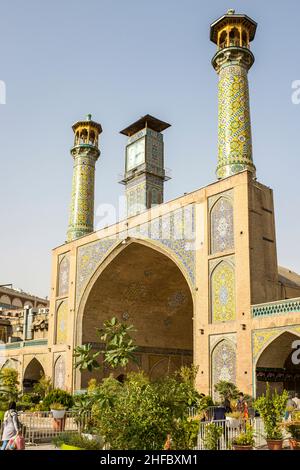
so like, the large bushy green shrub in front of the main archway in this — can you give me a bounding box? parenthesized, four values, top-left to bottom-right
(92, 371, 204, 450)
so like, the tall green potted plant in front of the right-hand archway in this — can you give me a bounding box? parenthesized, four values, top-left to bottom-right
(254, 383, 288, 450)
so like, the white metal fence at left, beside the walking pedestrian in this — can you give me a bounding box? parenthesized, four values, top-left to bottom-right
(0, 411, 90, 443)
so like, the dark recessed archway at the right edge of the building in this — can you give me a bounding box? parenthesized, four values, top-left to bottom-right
(256, 331, 300, 396)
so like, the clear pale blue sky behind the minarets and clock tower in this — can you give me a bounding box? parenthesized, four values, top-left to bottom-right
(0, 0, 300, 295)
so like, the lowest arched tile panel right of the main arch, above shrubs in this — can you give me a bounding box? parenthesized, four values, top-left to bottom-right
(211, 339, 236, 399)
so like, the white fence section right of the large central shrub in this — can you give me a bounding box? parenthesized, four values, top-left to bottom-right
(196, 418, 266, 450)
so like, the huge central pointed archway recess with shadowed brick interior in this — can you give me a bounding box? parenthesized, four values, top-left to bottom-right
(76, 241, 193, 388)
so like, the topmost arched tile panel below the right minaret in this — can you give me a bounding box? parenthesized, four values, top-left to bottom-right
(210, 197, 234, 253)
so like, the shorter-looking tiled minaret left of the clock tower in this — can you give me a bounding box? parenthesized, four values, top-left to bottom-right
(67, 114, 102, 242)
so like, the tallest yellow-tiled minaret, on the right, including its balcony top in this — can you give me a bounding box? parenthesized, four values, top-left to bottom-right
(210, 10, 257, 179)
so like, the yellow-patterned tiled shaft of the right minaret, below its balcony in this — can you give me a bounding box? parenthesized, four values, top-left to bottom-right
(217, 65, 255, 178)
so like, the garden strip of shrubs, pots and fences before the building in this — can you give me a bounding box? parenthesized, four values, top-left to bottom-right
(0, 318, 300, 450)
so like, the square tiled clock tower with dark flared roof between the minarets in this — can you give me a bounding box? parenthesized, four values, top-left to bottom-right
(121, 114, 170, 217)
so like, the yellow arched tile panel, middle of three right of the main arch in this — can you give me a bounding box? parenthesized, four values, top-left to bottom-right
(211, 261, 236, 322)
